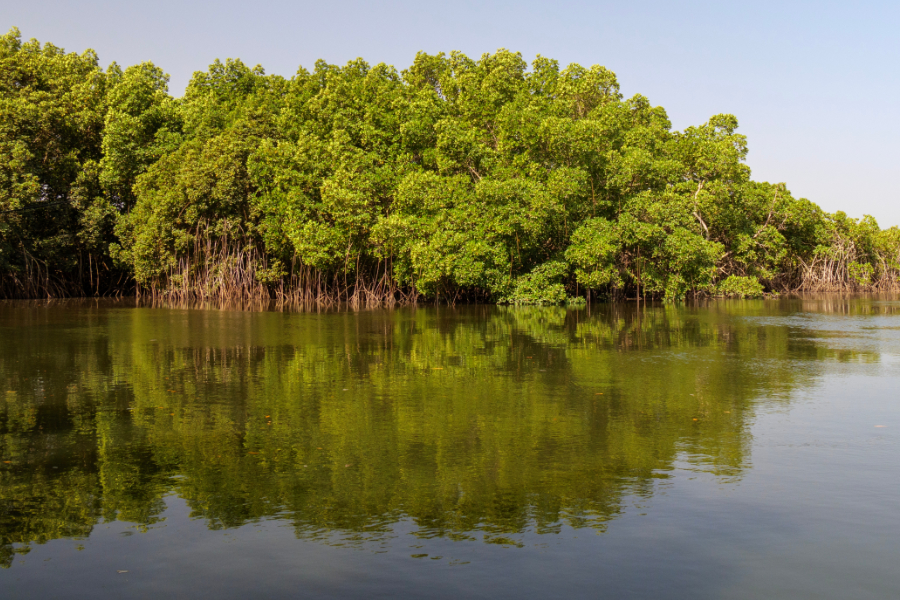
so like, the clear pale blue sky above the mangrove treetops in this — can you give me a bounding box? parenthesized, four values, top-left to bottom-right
(7, 0, 900, 227)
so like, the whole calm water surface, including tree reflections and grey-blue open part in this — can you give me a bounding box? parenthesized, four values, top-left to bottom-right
(0, 297, 900, 599)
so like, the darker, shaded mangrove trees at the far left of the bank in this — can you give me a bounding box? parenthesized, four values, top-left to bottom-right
(0, 29, 113, 297)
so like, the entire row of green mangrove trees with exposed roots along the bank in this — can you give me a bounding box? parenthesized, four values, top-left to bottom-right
(0, 29, 900, 304)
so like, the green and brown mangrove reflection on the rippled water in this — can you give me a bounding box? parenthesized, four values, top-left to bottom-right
(0, 301, 884, 566)
